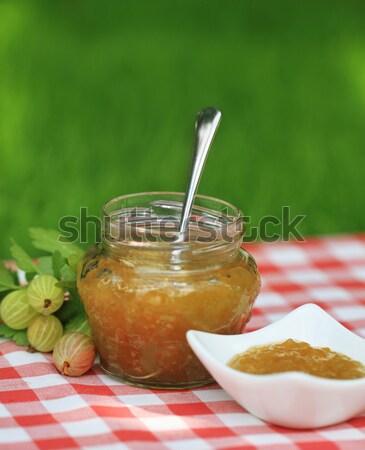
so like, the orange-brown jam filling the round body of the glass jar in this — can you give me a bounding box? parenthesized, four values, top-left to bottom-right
(78, 244, 260, 388)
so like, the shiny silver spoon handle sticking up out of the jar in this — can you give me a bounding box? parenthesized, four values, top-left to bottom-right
(179, 108, 222, 233)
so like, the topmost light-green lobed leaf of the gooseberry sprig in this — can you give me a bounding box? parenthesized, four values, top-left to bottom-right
(29, 228, 84, 258)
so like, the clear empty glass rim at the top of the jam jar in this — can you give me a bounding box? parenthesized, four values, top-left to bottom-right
(102, 191, 245, 254)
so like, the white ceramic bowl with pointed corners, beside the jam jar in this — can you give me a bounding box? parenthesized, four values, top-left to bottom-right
(187, 303, 365, 428)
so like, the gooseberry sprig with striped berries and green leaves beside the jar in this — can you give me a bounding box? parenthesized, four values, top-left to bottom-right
(0, 228, 95, 376)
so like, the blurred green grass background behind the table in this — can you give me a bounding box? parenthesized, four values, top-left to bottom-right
(0, 0, 365, 257)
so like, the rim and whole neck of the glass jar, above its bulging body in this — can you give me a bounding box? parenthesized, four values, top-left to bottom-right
(102, 192, 244, 270)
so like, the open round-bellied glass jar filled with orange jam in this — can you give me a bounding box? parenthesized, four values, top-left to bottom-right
(78, 192, 260, 389)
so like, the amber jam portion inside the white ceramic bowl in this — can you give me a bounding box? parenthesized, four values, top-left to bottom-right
(228, 339, 365, 380)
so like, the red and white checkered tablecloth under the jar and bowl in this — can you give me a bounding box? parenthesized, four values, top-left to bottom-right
(0, 234, 365, 450)
